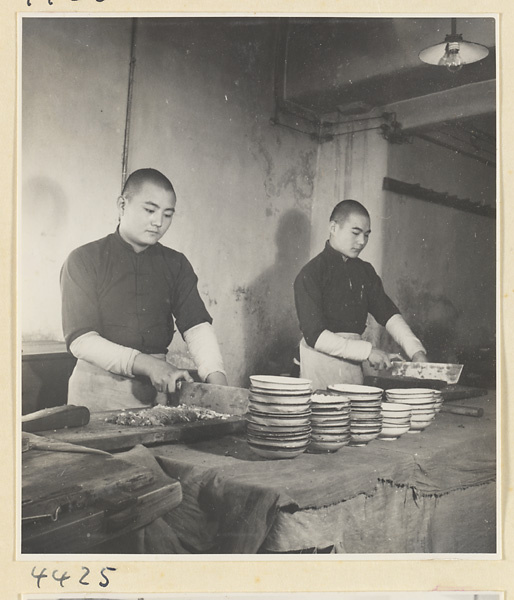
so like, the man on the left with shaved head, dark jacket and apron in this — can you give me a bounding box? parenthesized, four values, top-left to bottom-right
(61, 169, 227, 411)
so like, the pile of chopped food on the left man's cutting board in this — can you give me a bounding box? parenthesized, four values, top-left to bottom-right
(105, 404, 231, 427)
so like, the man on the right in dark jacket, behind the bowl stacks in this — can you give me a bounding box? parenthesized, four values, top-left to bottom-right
(294, 200, 427, 389)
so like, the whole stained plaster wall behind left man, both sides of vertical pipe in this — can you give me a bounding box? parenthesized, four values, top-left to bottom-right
(20, 19, 317, 385)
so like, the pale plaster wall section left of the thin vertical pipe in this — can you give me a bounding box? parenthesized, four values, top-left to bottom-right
(18, 19, 130, 341)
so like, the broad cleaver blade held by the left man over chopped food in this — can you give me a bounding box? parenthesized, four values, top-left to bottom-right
(170, 381, 250, 415)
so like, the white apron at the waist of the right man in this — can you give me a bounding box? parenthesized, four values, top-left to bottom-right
(300, 333, 363, 390)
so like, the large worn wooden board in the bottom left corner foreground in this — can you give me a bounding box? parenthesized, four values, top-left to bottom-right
(22, 450, 182, 553)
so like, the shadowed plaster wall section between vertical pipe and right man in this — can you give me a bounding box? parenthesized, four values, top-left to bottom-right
(124, 19, 317, 385)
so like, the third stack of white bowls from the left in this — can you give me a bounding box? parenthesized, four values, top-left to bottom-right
(328, 383, 383, 446)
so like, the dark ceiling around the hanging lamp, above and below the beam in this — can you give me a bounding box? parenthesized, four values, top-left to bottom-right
(282, 17, 496, 160)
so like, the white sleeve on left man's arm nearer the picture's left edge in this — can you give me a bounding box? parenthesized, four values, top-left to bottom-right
(70, 331, 140, 377)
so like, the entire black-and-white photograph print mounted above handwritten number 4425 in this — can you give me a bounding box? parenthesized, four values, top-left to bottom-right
(17, 13, 500, 556)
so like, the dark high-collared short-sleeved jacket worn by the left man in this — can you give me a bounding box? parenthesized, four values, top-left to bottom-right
(61, 231, 212, 354)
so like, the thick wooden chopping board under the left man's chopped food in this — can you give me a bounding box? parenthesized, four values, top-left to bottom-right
(40, 411, 245, 452)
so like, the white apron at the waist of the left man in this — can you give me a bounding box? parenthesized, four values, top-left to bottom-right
(68, 354, 167, 412)
